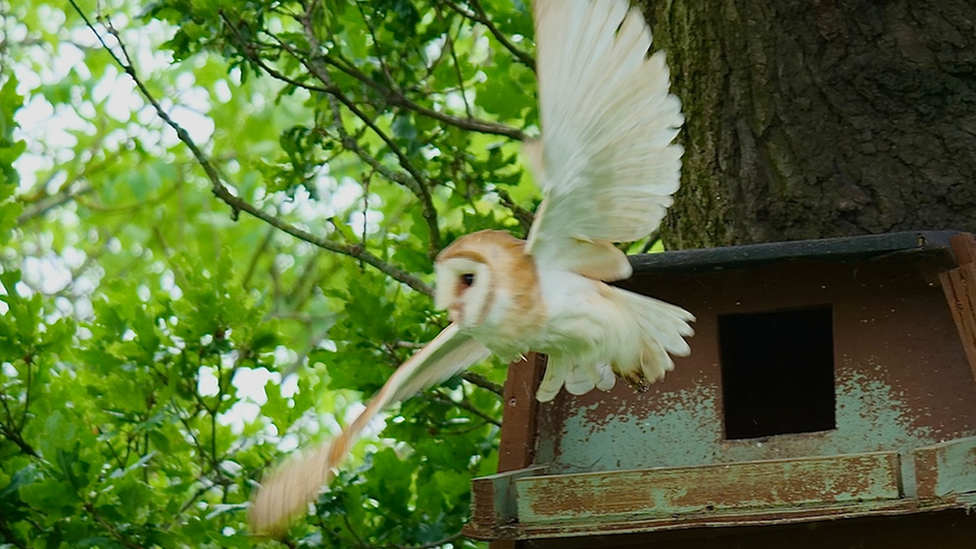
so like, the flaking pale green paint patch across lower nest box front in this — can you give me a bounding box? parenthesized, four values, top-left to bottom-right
(540, 364, 938, 484)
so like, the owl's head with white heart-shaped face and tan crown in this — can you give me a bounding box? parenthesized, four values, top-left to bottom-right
(434, 231, 537, 329)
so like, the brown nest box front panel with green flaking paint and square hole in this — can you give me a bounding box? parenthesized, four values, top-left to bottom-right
(534, 257, 976, 478)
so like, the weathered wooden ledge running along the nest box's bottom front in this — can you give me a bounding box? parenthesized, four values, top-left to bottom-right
(465, 437, 976, 540)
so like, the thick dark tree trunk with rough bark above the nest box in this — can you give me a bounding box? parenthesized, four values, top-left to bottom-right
(642, 0, 976, 248)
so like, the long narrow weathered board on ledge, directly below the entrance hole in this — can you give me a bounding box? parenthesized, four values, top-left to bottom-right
(515, 452, 900, 524)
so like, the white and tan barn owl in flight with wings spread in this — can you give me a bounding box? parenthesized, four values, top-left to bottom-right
(251, 0, 694, 531)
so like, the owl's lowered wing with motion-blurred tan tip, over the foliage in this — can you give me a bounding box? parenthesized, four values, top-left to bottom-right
(250, 324, 491, 533)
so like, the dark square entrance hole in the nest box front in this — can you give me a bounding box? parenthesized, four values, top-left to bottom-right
(718, 306, 836, 440)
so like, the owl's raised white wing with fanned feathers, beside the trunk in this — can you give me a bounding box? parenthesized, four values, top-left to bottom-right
(526, 0, 684, 281)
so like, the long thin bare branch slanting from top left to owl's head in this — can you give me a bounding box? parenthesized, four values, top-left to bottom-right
(69, 0, 434, 296)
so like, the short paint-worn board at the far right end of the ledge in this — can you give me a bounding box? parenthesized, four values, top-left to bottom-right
(915, 437, 976, 502)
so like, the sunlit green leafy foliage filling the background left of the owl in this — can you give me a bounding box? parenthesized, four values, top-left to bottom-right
(0, 0, 572, 549)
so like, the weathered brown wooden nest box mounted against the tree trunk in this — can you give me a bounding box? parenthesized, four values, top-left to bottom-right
(466, 232, 976, 549)
